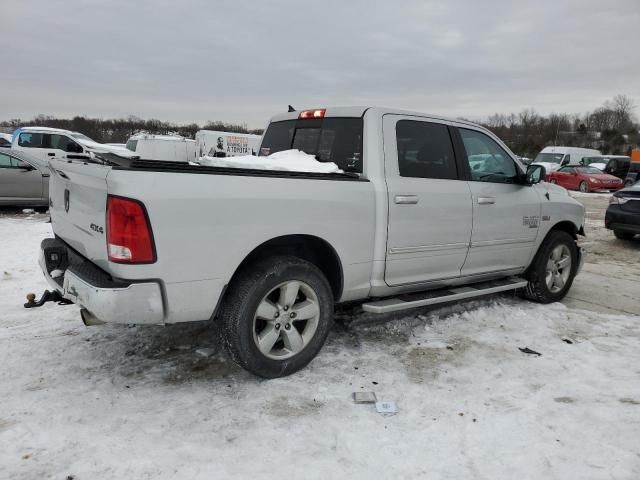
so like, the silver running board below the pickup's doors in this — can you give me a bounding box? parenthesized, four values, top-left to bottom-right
(362, 277, 528, 313)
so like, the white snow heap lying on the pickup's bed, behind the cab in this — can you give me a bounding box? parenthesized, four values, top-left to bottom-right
(198, 150, 342, 173)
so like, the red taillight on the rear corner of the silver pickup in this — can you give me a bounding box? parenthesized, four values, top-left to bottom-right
(107, 195, 156, 263)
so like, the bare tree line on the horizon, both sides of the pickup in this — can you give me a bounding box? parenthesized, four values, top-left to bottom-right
(0, 95, 640, 157)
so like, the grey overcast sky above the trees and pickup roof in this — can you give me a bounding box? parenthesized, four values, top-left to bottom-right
(0, 0, 640, 127)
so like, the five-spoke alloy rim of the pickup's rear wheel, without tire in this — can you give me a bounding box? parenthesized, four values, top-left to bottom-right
(253, 280, 320, 360)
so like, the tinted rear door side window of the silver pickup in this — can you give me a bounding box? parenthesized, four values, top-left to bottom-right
(396, 120, 458, 180)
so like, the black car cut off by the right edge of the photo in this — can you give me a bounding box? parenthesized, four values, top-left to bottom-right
(604, 183, 640, 240)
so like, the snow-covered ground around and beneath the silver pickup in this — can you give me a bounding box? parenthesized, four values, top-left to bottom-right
(0, 215, 640, 480)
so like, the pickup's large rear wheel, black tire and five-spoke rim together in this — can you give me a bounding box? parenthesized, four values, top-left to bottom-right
(219, 256, 333, 378)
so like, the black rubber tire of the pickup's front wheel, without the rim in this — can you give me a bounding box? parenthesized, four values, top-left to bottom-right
(522, 230, 578, 303)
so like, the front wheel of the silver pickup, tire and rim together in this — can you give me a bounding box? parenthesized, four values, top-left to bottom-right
(523, 230, 578, 303)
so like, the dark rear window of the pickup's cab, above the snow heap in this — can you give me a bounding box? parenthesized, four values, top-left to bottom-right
(259, 117, 362, 173)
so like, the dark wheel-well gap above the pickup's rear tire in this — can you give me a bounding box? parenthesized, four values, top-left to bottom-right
(229, 235, 344, 300)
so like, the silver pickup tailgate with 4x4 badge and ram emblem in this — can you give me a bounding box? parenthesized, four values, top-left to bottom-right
(49, 160, 111, 270)
